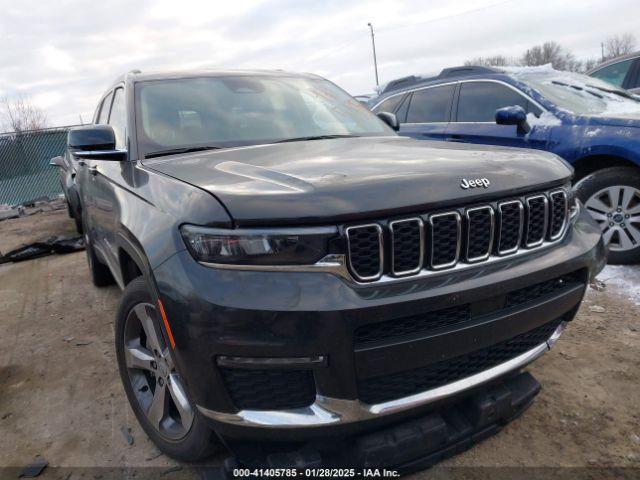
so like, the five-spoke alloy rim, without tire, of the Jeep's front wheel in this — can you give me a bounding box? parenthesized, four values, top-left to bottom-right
(124, 303, 193, 440)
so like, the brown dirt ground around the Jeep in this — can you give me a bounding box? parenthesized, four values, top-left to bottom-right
(0, 210, 640, 479)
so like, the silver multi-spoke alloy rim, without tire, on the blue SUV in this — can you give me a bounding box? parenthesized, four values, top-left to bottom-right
(585, 185, 640, 252)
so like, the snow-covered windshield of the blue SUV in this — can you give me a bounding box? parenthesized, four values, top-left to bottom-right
(514, 71, 640, 116)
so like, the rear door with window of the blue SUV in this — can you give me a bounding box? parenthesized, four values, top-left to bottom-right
(398, 83, 456, 140)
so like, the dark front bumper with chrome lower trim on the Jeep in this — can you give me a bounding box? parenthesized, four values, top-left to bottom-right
(154, 207, 606, 439)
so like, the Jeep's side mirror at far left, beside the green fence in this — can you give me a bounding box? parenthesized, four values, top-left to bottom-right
(67, 125, 127, 160)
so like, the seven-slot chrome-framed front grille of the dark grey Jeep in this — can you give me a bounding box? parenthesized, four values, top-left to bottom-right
(345, 190, 568, 282)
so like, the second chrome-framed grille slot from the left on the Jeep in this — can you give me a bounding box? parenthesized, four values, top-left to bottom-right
(389, 218, 424, 277)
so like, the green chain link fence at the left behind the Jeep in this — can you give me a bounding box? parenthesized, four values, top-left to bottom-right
(0, 127, 79, 205)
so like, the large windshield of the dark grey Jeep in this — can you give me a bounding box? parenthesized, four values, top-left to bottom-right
(136, 75, 394, 156)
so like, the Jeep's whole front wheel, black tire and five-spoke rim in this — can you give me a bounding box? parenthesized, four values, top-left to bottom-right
(116, 277, 219, 461)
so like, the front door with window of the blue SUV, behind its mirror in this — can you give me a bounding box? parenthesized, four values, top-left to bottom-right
(446, 80, 550, 149)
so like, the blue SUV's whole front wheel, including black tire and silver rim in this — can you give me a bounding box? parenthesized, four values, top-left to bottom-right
(575, 167, 640, 264)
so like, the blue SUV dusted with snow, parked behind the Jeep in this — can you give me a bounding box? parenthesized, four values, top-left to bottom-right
(368, 66, 640, 263)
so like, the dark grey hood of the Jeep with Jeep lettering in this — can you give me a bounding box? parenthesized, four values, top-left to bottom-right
(144, 136, 572, 226)
